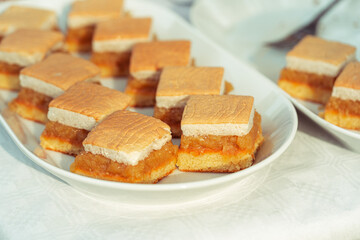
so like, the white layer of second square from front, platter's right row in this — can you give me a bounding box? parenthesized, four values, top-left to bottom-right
(156, 78, 225, 108)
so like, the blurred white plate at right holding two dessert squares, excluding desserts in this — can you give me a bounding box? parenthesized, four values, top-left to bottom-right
(190, 0, 360, 152)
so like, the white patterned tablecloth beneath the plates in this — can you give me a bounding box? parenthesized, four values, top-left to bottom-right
(0, 0, 360, 239)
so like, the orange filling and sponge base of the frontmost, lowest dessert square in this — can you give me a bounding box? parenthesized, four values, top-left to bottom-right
(70, 141, 178, 183)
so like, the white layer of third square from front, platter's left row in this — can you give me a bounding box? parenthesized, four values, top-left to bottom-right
(19, 74, 100, 98)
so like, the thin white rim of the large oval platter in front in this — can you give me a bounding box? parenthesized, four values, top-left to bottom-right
(0, 0, 298, 192)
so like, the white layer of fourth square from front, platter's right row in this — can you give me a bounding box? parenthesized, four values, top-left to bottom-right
(93, 38, 149, 52)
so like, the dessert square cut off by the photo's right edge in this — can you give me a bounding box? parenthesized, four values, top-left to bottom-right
(324, 62, 360, 130)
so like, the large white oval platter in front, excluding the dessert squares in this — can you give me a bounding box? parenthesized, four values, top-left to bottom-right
(0, 0, 297, 204)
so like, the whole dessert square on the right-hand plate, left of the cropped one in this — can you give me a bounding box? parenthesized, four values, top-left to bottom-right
(278, 36, 356, 104)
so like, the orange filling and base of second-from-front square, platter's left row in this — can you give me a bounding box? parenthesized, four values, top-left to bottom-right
(40, 121, 89, 155)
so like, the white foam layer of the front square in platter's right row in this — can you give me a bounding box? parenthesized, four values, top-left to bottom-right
(181, 107, 255, 136)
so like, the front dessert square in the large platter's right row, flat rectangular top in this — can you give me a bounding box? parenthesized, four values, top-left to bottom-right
(176, 95, 264, 172)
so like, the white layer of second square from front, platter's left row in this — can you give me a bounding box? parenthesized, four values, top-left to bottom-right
(47, 107, 96, 131)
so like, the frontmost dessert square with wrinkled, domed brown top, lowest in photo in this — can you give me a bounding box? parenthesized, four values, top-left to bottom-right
(70, 110, 178, 183)
